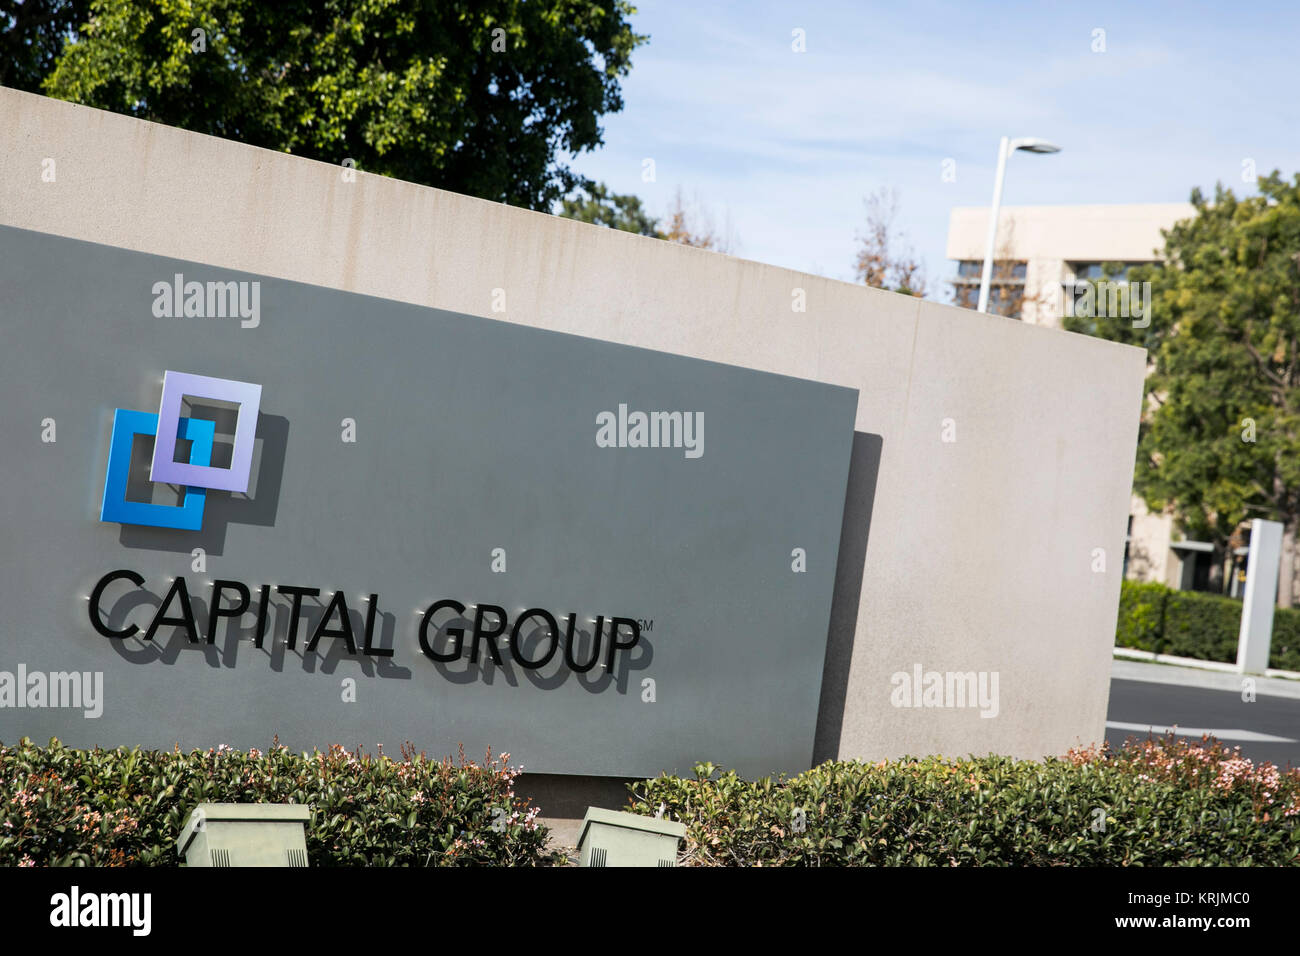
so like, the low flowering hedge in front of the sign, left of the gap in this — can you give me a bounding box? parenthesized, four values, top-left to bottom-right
(0, 739, 555, 866)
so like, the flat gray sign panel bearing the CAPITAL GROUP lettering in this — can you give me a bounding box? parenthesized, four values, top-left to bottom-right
(0, 228, 857, 775)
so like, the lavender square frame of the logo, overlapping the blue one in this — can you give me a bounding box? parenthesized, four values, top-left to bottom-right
(150, 372, 261, 493)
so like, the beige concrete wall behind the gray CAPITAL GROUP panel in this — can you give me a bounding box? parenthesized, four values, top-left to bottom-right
(0, 90, 1145, 760)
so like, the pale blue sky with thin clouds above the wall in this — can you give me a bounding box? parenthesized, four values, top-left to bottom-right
(573, 0, 1300, 298)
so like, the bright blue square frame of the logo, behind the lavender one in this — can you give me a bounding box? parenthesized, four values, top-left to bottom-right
(99, 408, 217, 531)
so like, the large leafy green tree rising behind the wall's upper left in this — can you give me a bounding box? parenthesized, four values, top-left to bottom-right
(44, 0, 646, 209)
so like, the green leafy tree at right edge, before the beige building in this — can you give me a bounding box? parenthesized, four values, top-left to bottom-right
(1066, 172, 1300, 606)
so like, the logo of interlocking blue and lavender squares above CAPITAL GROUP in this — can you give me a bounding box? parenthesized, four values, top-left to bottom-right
(99, 371, 261, 531)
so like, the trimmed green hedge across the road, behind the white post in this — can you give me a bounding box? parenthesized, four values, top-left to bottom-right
(1115, 581, 1300, 670)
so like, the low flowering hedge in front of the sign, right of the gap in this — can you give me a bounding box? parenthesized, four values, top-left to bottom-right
(629, 737, 1300, 866)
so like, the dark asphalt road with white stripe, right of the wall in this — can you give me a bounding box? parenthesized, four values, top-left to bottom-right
(1106, 679, 1300, 767)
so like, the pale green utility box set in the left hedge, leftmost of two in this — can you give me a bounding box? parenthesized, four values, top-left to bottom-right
(176, 804, 312, 866)
